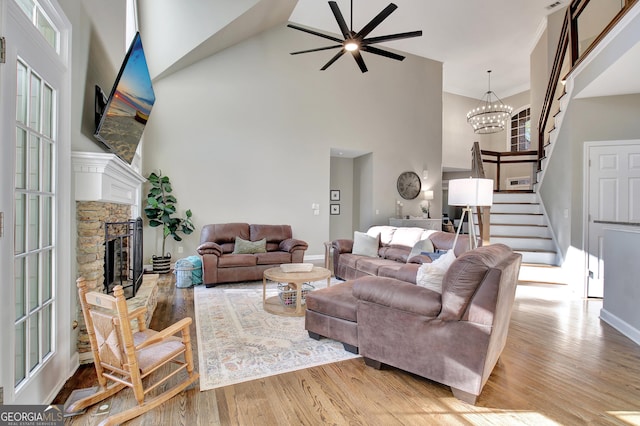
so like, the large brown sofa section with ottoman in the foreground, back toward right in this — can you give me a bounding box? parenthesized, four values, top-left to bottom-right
(305, 244, 522, 404)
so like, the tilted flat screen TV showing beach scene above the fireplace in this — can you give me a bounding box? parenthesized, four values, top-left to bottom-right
(94, 33, 156, 164)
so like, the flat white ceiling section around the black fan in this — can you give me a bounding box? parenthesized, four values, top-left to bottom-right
(290, 0, 568, 98)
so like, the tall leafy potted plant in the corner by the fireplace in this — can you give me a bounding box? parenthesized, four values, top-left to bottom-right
(144, 172, 195, 274)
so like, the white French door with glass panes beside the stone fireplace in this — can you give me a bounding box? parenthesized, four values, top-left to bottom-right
(0, 0, 71, 404)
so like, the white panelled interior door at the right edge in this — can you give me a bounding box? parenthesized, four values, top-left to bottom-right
(587, 141, 640, 297)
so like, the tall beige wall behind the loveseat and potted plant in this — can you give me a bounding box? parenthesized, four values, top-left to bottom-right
(143, 26, 442, 258)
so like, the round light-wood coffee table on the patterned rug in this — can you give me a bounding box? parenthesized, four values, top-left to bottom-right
(262, 266, 331, 317)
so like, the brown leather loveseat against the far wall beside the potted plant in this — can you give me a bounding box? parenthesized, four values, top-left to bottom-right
(198, 223, 308, 287)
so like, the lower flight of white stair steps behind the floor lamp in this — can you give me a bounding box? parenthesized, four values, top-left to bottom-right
(482, 192, 558, 265)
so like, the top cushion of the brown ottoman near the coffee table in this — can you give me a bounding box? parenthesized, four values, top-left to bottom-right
(306, 281, 358, 322)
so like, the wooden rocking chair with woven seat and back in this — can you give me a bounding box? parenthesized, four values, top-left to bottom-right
(67, 278, 198, 425)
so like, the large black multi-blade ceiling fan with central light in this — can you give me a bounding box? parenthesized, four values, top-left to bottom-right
(287, 0, 422, 73)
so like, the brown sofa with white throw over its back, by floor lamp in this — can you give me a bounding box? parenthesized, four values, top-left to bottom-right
(331, 226, 469, 284)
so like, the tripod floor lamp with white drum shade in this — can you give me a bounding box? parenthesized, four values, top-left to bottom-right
(448, 178, 493, 250)
